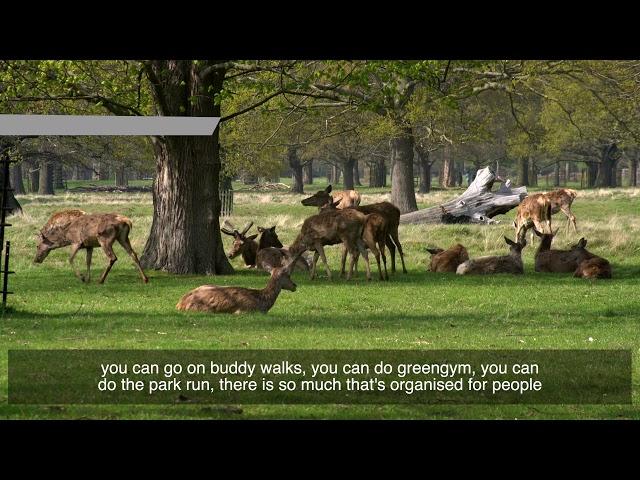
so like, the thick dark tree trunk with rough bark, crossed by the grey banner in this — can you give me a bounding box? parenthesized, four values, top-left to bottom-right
(142, 60, 233, 275)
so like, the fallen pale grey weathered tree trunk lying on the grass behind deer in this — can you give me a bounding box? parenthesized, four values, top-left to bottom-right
(400, 167, 527, 224)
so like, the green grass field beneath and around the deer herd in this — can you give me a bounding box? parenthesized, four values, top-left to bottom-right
(0, 184, 640, 419)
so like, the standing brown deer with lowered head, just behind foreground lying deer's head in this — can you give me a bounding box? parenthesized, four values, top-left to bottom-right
(289, 204, 371, 280)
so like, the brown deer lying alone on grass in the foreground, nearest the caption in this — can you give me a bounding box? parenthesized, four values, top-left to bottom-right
(176, 251, 298, 314)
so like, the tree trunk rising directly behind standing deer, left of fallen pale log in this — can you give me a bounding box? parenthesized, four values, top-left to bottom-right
(391, 127, 418, 213)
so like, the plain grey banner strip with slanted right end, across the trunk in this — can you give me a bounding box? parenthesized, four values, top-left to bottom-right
(0, 115, 220, 136)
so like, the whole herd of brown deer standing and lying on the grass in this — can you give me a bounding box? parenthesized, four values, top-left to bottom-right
(34, 185, 611, 313)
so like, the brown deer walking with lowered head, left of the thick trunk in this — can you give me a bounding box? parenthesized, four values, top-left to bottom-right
(34, 210, 149, 283)
